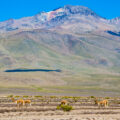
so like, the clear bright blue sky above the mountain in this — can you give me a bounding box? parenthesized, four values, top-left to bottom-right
(0, 0, 120, 21)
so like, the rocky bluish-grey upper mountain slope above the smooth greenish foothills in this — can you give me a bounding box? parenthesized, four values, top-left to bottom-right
(0, 5, 119, 32)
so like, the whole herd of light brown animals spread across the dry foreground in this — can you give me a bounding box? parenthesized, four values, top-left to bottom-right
(11, 98, 108, 108)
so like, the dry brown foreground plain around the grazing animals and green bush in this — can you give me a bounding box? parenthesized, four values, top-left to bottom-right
(0, 96, 120, 120)
